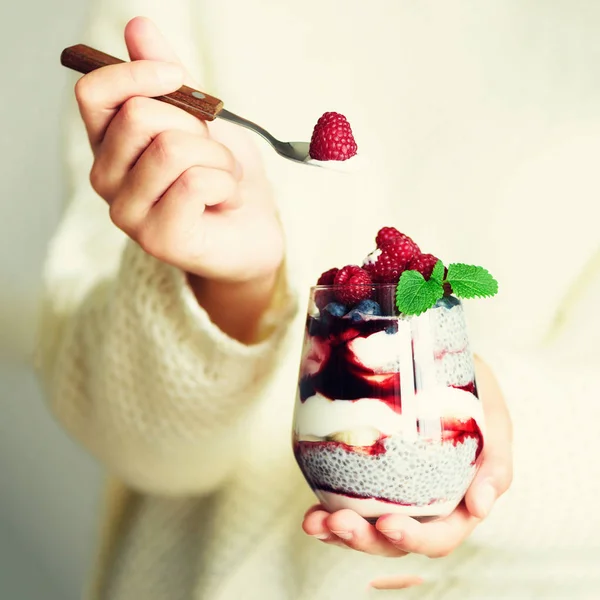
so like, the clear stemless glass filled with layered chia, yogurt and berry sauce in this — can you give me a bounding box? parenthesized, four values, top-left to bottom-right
(293, 284, 484, 520)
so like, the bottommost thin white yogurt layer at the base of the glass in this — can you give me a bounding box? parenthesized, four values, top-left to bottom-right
(315, 490, 460, 518)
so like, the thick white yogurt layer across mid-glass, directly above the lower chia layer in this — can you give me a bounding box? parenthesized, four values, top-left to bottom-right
(294, 387, 483, 445)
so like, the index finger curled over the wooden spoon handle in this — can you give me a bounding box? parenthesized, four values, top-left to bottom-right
(75, 60, 184, 152)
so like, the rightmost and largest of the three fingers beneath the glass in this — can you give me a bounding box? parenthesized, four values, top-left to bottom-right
(375, 504, 480, 558)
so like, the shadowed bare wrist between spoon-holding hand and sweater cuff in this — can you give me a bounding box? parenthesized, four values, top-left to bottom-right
(186, 269, 278, 344)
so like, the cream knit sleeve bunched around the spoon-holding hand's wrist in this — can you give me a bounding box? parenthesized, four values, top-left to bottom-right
(40, 223, 293, 494)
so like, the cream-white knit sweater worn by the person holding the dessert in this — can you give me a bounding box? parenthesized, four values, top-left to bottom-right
(39, 0, 600, 600)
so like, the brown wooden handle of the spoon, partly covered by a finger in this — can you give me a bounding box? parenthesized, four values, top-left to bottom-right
(60, 44, 223, 121)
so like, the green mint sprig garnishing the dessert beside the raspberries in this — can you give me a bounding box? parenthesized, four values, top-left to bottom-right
(396, 260, 498, 315)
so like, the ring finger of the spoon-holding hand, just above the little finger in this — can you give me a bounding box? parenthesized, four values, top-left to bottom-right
(110, 130, 236, 236)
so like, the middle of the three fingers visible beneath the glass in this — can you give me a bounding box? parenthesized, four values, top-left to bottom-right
(327, 509, 406, 556)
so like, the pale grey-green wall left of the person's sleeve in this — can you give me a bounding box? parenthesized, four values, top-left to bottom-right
(0, 0, 100, 600)
